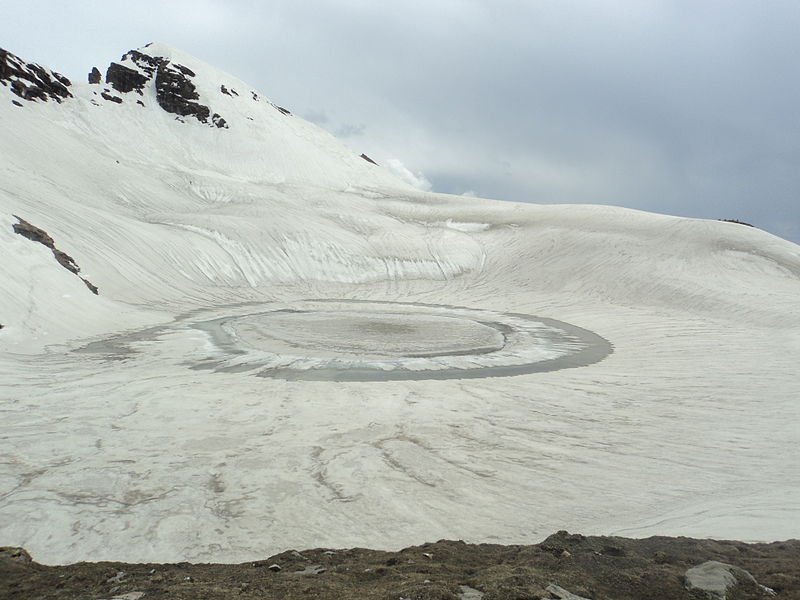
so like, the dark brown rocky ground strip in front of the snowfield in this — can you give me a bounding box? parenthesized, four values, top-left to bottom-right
(0, 531, 800, 600)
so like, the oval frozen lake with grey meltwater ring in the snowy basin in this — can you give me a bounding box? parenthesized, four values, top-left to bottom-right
(191, 300, 612, 381)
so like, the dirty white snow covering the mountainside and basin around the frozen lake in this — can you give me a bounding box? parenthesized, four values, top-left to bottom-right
(0, 44, 800, 562)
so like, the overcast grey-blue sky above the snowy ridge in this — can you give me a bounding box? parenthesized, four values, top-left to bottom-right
(6, 0, 800, 242)
